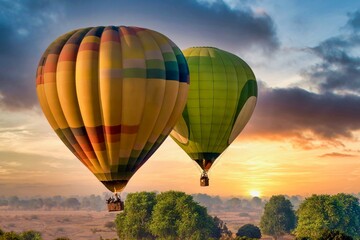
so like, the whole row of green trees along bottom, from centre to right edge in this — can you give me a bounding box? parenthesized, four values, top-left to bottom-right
(115, 191, 360, 240)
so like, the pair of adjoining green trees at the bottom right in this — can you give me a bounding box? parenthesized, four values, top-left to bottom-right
(260, 193, 360, 240)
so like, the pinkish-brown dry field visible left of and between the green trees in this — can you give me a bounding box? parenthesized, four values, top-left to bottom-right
(0, 209, 293, 240)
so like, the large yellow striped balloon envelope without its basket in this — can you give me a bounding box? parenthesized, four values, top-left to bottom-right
(36, 26, 189, 209)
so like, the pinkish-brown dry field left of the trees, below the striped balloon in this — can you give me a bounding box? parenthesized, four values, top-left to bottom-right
(0, 210, 116, 240)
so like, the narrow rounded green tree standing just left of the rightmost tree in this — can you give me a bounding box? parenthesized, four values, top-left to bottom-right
(260, 195, 296, 239)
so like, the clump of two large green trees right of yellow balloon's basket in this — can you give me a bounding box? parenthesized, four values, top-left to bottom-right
(115, 191, 220, 240)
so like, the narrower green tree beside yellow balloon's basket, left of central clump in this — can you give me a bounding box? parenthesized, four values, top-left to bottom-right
(115, 192, 156, 239)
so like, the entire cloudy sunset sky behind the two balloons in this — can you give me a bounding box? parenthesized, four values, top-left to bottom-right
(0, 0, 360, 196)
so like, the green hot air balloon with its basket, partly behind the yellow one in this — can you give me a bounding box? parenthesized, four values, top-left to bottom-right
(171, 47, 257, 186)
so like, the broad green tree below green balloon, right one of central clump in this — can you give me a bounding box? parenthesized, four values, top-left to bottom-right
(150, 191, 220, 240)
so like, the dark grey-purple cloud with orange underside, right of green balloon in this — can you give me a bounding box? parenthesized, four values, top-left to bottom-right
(246, 84, 360, 145)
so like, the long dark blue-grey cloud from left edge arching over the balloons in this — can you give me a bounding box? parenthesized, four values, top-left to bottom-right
(0, 0, 279, 109)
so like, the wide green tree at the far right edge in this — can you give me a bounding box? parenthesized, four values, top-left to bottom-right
(295, 194, 360, 239)
